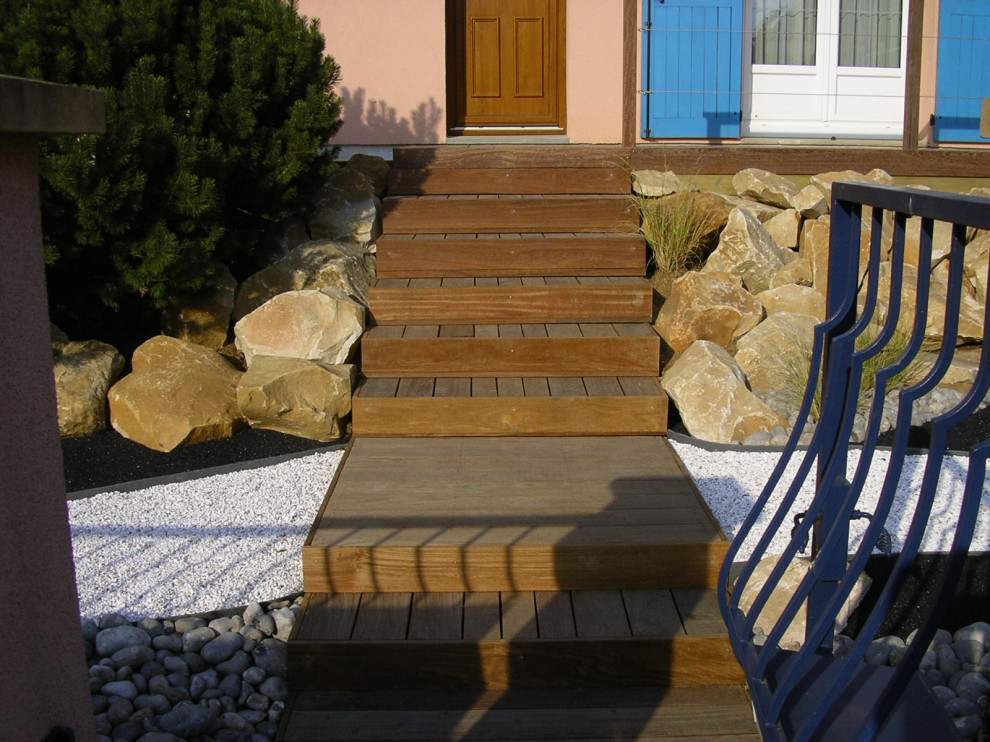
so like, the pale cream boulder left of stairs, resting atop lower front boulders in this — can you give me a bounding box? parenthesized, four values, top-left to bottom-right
(234, 288, 365, 369)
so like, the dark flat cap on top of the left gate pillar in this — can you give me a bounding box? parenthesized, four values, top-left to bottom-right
(0, 75, 106, 134)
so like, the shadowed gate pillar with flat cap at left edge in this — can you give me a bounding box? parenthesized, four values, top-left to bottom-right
(0, 77, 104, 742)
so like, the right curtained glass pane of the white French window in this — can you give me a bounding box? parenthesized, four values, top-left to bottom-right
(839, 0, 903, 68)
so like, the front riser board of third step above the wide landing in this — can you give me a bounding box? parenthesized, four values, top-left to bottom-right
(370, 282, 653, 325)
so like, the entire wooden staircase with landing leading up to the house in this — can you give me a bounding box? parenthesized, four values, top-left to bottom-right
(280, 148, 759, 742)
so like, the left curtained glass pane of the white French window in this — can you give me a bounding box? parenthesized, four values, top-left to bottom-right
(753, 0, 818, 65)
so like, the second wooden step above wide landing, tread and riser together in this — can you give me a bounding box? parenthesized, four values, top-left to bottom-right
(361, 324, 660, 378)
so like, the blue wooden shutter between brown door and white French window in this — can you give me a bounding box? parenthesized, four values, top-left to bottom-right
(643, 0, 743, 138)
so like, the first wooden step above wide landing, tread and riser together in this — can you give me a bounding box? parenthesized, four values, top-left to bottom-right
(352, 376, 667, 436)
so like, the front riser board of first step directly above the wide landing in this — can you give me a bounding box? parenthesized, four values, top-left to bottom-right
(352, 396, 667, 437)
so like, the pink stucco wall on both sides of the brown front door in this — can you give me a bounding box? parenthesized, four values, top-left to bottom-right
(299, 0, 622, 145)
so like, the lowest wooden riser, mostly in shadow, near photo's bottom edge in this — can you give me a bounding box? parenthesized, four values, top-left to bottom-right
(289, 637, 745, 691)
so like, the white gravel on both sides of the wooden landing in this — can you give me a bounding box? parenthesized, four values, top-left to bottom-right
(69, 441, 990, 619)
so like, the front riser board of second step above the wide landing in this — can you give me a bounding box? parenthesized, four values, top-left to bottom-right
(361, 337, 660, 378)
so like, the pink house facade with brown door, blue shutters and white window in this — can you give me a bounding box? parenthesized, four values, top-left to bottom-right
(299, 0, 990, 154)
